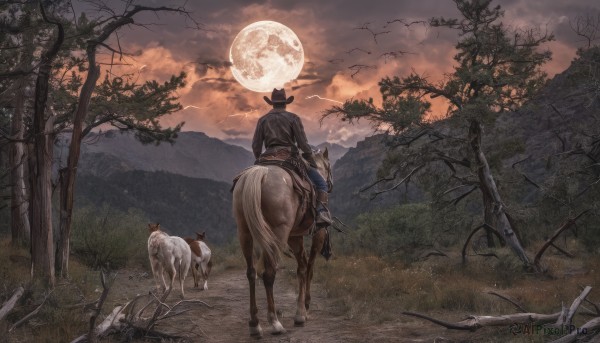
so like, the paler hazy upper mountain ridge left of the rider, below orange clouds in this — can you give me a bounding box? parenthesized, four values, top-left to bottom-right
(62, 131, 254, 182)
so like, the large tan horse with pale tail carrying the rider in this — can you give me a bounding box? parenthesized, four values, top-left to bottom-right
(233, 149, 333, 337)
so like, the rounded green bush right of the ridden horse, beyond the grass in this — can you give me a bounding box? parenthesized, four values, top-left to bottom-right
(339, 203, 435, 256)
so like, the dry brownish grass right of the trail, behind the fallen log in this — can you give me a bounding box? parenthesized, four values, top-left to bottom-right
(315, 241, 600, 330)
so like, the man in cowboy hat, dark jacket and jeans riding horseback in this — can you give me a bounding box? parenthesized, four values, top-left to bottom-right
(252, 88, 331, 227)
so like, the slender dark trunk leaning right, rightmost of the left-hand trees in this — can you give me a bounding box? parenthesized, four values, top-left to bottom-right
(56, 46, 100, 277)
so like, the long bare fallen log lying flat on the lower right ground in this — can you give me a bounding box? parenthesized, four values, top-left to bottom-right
(402, 312, 561, 331)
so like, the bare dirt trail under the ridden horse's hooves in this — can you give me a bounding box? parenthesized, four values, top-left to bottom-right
(105, 264, 492, 343)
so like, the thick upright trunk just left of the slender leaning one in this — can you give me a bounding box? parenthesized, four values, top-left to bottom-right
(30, 63, 55, 287)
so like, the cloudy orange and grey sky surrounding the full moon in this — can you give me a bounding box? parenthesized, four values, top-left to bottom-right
(82, 0, 600, 146)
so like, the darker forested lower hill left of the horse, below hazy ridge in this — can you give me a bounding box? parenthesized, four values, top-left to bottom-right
(75, 170, 236, 244)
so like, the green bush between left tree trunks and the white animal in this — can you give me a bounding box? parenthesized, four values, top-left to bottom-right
(71, 205, 148, 269)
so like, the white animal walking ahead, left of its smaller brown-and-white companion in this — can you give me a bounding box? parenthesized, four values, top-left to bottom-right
(148, 224, 192, 299)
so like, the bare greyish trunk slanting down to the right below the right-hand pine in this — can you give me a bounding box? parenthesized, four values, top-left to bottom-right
(469, 120, 531, 266)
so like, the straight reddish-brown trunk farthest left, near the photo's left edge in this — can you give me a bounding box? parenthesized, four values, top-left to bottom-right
(9, 82, 31, 246)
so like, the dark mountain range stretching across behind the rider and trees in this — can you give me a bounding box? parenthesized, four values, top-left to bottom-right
(70, 48, 600, 243)
